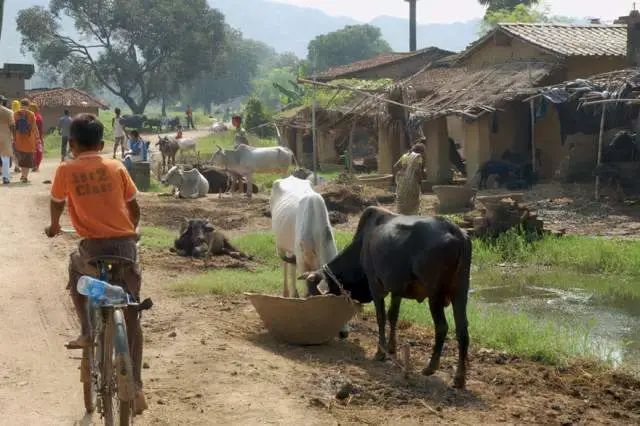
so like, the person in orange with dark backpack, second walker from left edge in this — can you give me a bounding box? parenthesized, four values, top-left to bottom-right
(13, 99, 38, 183)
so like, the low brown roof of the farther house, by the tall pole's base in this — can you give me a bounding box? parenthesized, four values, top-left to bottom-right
(314, 47, 453, 81)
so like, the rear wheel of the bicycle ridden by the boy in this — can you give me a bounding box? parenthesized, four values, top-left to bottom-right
(102, 309, 134, 426)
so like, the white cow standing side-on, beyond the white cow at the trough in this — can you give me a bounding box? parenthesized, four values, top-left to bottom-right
(211, 145, 296, 198)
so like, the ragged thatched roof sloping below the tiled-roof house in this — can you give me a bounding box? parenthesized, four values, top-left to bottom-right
(403, 62, 558, 118)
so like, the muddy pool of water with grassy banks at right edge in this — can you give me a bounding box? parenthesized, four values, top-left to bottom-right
(472, 268, 640, 371)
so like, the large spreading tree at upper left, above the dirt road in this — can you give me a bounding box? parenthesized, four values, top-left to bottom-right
(17, 0, 225, 114)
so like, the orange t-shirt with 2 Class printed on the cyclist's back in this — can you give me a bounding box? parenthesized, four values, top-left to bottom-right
(51, 152, 138, 239)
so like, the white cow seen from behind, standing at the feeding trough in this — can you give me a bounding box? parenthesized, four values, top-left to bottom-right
(270, 176, 338, 297)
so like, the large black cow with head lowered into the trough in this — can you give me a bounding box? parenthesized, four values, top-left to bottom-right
(301, 207, 471, 387)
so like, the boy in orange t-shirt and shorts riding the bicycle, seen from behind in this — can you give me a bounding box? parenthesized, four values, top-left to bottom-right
(46, 114, 147, 414)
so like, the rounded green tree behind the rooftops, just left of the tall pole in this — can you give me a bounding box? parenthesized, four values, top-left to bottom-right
(307, 24, 391, 71)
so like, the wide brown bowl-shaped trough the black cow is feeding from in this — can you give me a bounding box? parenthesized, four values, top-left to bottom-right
(245, 293, 356, 345)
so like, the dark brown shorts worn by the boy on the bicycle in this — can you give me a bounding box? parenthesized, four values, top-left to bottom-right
(67, 237, 142, 298)
